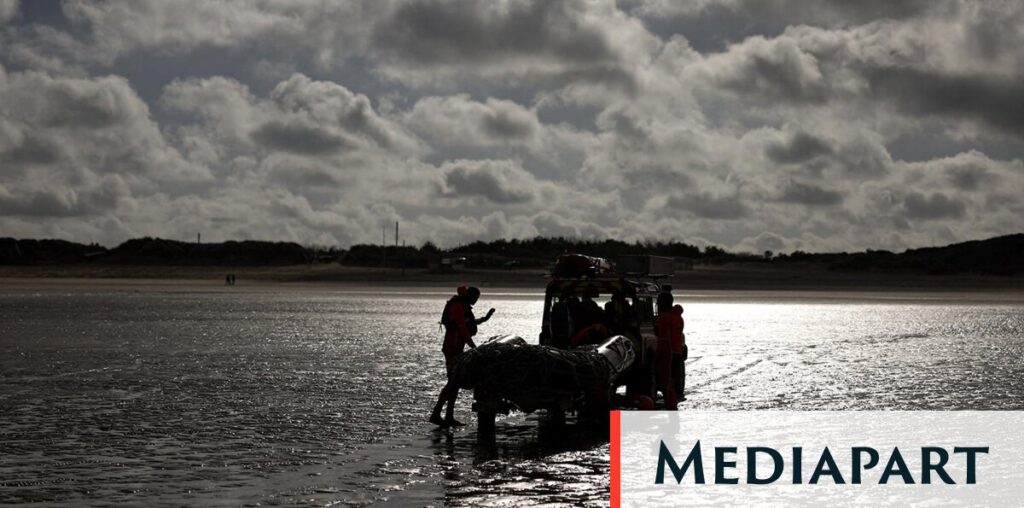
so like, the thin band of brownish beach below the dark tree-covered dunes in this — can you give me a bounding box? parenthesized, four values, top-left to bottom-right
(0, 263, 1024, 294)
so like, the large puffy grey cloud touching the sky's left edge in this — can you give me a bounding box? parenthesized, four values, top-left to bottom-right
(0, 68, 209, 187)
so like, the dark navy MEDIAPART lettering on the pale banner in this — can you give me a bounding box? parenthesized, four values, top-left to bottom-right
(654, 440, 988, 485)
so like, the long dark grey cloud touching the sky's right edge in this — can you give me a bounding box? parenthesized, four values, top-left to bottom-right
(867, 68, 1024, 135)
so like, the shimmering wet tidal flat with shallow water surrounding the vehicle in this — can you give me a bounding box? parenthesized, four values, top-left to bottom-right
(0, 288, 1024, 506)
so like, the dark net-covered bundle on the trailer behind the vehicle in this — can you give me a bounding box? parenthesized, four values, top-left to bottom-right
(451, 342, 613, 412)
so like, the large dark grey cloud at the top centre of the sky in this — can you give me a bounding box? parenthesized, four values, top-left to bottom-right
(371, 0, 637, 93)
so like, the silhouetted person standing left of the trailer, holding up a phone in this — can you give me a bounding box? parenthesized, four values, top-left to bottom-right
(430, 285, 495, 427)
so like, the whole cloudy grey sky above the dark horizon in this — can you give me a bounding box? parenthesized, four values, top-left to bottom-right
(0, 0, 1024, 252)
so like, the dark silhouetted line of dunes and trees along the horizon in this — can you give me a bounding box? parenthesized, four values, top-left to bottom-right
(0, 235, 1024, 276)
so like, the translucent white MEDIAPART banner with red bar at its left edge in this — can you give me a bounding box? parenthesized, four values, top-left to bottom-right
(611, 411, 1024, 507)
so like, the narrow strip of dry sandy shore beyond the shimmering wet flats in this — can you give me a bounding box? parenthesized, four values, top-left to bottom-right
(0, 264, 1024, 302)
